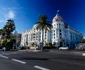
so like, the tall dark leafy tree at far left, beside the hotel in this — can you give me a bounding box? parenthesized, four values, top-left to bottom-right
(0, 20, 15, 49)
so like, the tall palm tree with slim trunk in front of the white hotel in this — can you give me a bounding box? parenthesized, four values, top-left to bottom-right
(36, 15, 52, 50)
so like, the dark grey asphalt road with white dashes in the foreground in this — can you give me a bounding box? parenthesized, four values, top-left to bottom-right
(0, 51, 85, 70)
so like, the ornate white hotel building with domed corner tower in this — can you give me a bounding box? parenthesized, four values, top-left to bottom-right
(21, 14, 83, 47)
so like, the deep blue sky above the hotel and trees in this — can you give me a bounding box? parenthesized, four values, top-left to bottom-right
(0, 0, 85, 36)
